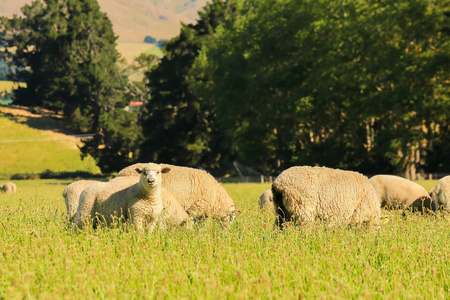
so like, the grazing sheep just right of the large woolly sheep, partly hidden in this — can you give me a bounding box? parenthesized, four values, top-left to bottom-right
(370, 175, 436, 212)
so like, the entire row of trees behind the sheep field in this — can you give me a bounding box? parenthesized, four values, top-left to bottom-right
(1, 0, 450, 176)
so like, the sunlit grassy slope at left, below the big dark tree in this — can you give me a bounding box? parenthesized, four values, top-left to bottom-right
(0, 107, 99, 178)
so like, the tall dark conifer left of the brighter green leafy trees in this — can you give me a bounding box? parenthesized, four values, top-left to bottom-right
(140, 0, 231, 169)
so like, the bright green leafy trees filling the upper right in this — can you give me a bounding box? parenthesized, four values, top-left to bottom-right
(191, 0, 450, 174)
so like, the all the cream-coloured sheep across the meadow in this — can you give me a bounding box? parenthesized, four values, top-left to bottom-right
(0, 163, 450, 232)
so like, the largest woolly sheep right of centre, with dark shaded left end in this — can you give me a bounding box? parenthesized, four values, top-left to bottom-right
(272, 166, 381, 229)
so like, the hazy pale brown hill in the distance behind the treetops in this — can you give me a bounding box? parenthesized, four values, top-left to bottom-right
(0, 0, 208, 42)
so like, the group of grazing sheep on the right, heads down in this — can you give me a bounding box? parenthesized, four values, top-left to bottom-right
(259, 166, 450, 227)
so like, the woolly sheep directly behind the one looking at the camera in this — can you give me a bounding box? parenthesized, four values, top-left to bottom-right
(117, 163, 240, 224)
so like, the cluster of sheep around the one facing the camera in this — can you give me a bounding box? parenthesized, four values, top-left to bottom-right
(63, 163, 239, 232)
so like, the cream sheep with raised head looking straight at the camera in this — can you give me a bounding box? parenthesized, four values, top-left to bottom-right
(75, 163, 170, 232)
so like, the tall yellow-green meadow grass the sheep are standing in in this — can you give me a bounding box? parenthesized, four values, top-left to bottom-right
(0, 180, 450, 299)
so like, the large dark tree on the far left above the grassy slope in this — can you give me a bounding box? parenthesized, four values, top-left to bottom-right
(0, 0, 127, 132)
